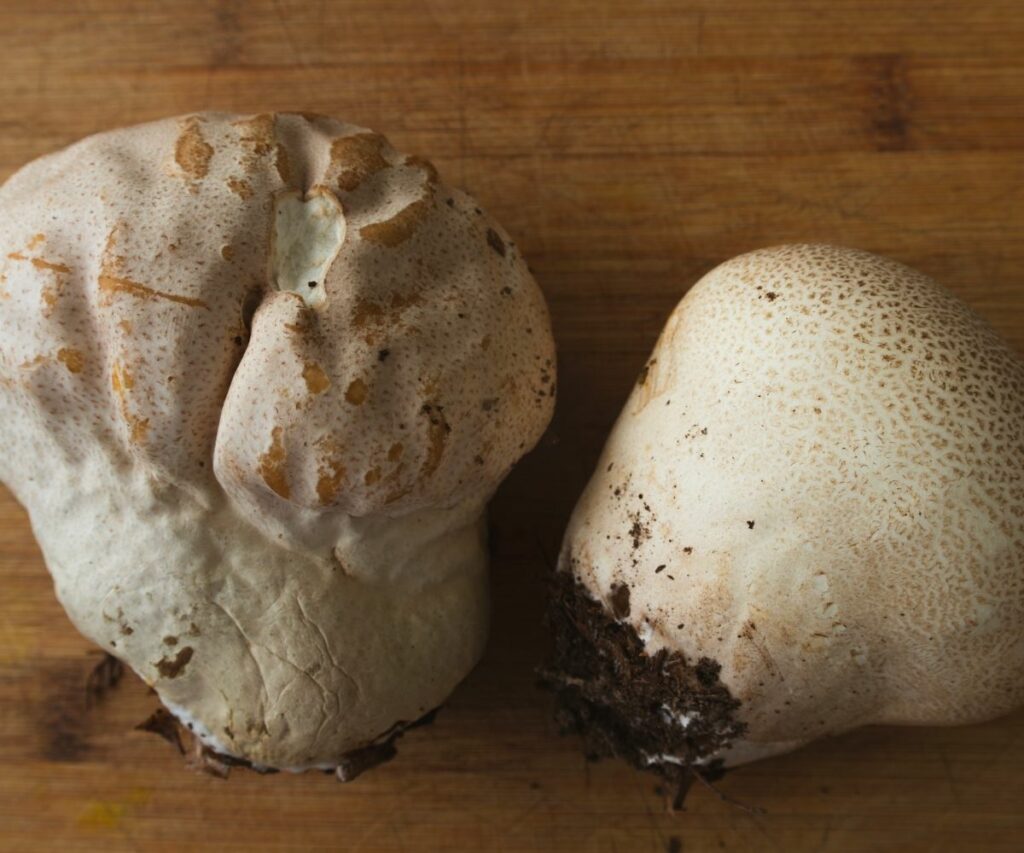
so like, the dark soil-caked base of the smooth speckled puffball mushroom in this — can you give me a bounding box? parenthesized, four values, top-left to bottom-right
(543, 571, 746, 783)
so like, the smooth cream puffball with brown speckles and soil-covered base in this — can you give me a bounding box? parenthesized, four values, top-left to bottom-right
(549, 246, 1024, 778)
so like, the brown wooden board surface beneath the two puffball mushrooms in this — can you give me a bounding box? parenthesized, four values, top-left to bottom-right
(0, 0, 1024, 851)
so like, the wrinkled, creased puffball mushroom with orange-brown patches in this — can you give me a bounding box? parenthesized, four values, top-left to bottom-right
(0, 113, 555, 768)
